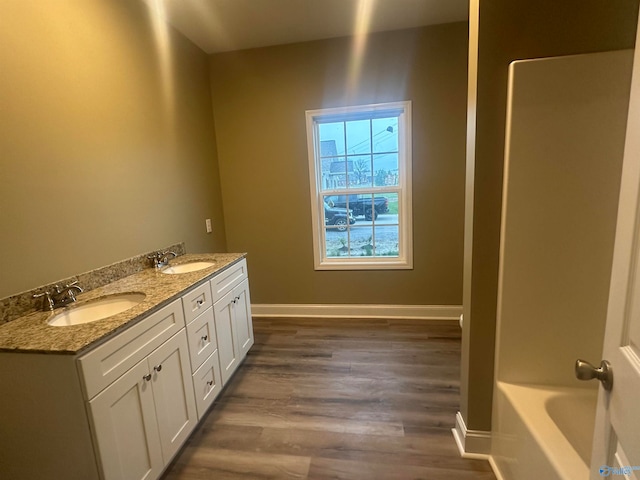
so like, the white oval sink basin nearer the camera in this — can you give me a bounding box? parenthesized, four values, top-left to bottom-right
(47, 293, 146, 327)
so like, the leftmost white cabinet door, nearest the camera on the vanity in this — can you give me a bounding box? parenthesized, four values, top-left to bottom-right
(89, 360, 164, 480)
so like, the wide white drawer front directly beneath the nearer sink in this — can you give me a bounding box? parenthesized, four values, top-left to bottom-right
(78, 300, 184, 399)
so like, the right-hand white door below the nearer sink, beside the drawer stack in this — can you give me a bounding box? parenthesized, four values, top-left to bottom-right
(147, 330, 197, 463)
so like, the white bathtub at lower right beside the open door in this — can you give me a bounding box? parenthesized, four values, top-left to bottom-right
(491, 382, 597, 480)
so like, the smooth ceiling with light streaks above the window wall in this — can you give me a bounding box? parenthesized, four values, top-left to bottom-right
(151, 0, 468, 53)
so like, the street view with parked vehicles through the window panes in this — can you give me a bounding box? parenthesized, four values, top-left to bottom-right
(319, 117, 399, 257)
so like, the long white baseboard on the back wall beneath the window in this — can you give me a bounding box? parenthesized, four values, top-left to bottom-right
(251, 303, 462, 322)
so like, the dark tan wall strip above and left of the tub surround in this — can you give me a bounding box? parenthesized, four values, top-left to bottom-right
(461, 0, 638, 430)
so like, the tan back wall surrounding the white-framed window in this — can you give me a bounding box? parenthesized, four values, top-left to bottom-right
(211, 23, 467, 305)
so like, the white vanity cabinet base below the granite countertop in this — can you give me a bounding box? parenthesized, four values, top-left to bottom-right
(0, 259, 253, 480)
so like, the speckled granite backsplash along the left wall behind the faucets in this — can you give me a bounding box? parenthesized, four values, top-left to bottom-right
(0, 242, 186, 325)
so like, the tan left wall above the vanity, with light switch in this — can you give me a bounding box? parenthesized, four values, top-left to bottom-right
(0, 0, 225, 298)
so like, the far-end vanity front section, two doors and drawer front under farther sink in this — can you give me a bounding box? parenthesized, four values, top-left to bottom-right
(211, 260, 254, 385)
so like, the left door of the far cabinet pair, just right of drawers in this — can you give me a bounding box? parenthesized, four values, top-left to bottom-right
(213, 290, 240, 385)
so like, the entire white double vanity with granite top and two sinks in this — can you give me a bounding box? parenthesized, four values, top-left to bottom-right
(0, 254, 253, 480)
